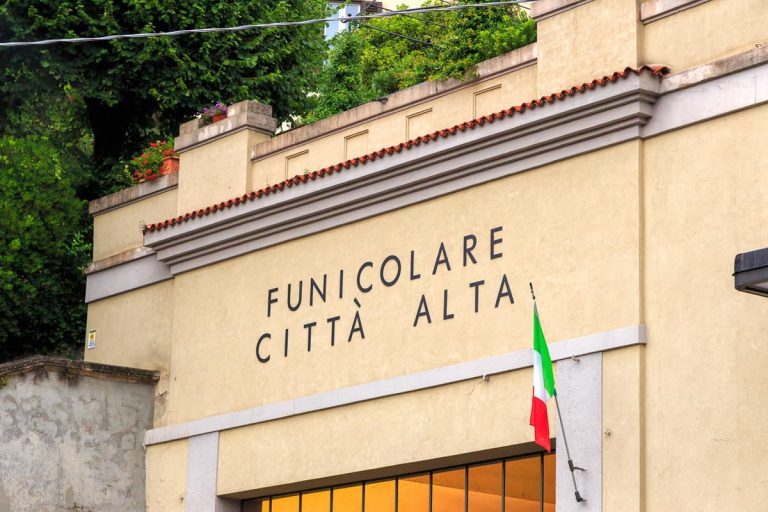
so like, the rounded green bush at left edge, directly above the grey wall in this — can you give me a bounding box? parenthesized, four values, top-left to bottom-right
(0, 136, 90, 360)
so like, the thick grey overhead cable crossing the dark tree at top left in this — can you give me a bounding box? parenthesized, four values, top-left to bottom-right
(0, 0, 530, 48)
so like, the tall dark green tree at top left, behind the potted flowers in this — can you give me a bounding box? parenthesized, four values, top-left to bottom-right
(0, 0, 326, 176)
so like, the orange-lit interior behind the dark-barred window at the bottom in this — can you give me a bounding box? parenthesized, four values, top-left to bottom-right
(242, 453, 555, 512)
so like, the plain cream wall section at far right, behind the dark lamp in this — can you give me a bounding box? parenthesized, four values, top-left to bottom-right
(644, 106, 768, 510)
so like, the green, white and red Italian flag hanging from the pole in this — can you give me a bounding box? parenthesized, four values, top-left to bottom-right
(531, 302, 555, 452)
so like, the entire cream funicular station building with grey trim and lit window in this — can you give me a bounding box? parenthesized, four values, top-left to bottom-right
(85, 0, 768, 512)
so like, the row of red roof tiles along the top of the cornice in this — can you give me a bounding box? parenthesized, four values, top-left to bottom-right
(143, 65, 670, 233)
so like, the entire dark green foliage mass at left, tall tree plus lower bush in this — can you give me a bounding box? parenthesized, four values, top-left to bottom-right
(0, 0, 326, 361)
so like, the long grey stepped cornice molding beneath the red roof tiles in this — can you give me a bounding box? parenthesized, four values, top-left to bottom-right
(86, 55, 768, 302)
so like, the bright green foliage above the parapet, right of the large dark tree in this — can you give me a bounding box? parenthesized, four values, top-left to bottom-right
(305, 0, 536, 122)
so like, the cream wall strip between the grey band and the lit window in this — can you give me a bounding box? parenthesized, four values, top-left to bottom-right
(218, 370, 554, 494)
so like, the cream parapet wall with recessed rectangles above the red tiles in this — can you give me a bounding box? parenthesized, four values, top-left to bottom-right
(251, 65, 536, 189)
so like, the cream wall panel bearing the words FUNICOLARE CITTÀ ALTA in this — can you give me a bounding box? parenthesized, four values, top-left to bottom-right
(168, 142, 639, 423)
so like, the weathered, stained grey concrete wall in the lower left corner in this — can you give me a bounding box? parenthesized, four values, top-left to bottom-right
(0, 368, 153, 512)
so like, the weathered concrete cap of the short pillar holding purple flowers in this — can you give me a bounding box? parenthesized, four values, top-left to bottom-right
(173, 100, 277, 152)
